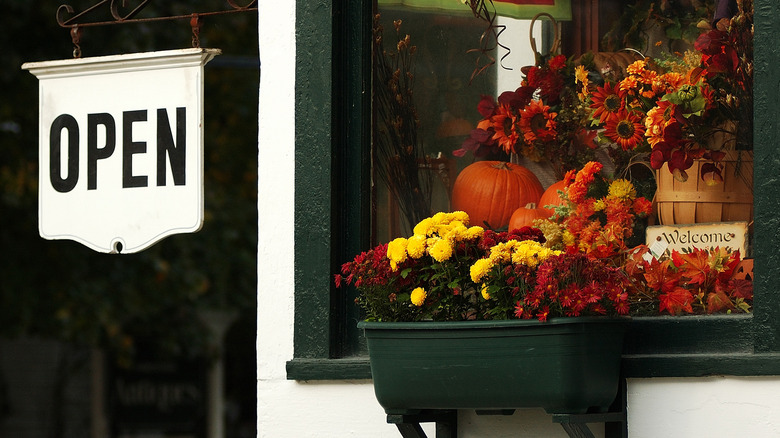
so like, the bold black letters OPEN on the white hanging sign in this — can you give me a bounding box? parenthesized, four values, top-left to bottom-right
(49, 107, 187, 193)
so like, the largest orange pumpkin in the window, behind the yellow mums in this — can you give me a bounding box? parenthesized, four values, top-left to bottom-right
(452, 161, 544, 229)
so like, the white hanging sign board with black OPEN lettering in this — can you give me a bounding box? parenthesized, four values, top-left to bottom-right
(22, 48, 220, 253)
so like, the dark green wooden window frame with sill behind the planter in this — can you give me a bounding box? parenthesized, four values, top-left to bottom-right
(287, 0, 780, 380)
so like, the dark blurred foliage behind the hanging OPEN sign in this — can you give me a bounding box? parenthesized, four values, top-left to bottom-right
(0, 0, 259, 368)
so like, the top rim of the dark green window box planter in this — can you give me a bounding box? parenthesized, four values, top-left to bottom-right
(357, 316, 631, 330)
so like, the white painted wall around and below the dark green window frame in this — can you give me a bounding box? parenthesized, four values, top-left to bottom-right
(257, 4, 780, 438)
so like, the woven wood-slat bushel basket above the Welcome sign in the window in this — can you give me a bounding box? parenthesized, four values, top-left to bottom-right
(655, 151, 753, 225)
